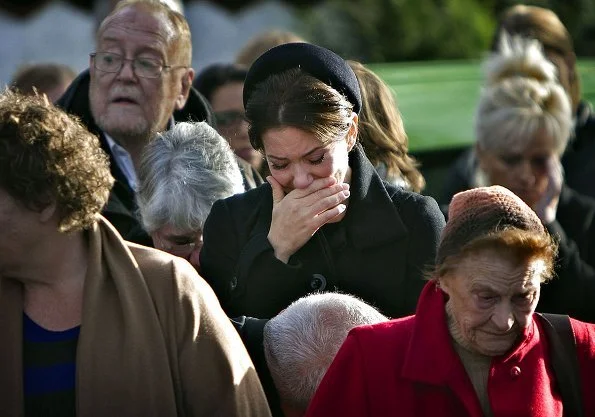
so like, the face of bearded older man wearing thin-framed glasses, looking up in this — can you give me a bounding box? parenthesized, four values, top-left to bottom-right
(89, 7, 194, 139)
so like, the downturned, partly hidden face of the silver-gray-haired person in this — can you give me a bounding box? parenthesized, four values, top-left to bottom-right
(151, 225, 202, 272)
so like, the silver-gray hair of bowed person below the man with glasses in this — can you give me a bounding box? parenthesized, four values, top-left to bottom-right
(137, 122, 244, 233)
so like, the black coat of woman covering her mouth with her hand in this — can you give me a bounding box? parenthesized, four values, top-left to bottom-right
(200, 145, 444, 318)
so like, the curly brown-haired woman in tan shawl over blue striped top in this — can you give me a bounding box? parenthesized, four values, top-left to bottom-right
(0, 91, 269, 416)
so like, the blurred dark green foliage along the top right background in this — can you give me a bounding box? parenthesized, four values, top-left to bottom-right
(298, 0, 595, 62)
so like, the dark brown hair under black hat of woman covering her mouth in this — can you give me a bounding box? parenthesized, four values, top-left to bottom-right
(246, 68, 353, 152)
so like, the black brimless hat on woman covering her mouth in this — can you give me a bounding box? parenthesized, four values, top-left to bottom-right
(244, 42, 362, 113)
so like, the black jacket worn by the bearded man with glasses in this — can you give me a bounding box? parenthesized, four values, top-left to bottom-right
(57, 70, 214, 246)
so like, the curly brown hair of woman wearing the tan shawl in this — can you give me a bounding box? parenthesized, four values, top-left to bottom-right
(0, 90, 113, 232)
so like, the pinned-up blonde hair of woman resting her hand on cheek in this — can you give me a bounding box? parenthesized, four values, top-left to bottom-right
(475, 33, 572, 155)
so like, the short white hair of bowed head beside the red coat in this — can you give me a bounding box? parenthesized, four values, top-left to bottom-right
(263, 293, 388, 411)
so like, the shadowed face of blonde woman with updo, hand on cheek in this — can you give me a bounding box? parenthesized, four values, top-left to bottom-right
(477, 130, 560, 207)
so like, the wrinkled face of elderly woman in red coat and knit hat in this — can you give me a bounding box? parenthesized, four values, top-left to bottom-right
(440, 245, 545, 356)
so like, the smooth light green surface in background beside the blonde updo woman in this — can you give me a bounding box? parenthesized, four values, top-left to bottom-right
(369, 60, 595, 151)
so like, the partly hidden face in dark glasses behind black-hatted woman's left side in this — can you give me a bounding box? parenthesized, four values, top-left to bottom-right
(211, 81, 263, 170)
